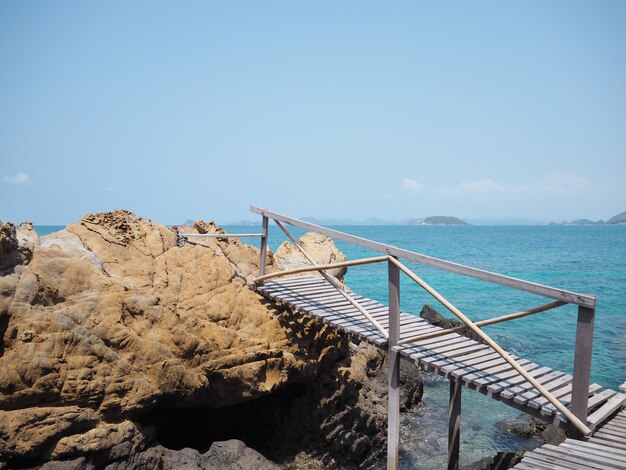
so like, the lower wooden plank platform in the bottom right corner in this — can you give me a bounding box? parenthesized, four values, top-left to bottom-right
(513, 410, 626, 470)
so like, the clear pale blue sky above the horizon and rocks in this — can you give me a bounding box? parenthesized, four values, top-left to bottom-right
(0, 0, 626, 224)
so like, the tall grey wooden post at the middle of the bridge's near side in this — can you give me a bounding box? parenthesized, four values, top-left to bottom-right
(387, 262, 400, 470)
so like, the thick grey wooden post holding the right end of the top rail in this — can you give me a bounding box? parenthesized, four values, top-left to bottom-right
(571, 306, 595, 437)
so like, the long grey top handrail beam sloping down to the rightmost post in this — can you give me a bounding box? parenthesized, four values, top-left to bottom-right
(250, 206, 596, 308)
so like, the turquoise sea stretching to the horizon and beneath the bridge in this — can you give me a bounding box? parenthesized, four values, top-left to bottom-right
(35, 225, 626, 469)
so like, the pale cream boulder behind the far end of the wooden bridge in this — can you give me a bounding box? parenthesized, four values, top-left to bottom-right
(274, 233, 347, 279)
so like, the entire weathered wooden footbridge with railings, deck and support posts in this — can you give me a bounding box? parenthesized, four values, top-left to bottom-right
(178, 206, 626, 469)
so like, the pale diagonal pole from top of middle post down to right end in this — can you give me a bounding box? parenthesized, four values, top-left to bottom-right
(389, 256, 591, 435)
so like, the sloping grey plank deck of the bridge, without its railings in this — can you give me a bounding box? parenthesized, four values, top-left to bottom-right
(256, 276, 626, 430)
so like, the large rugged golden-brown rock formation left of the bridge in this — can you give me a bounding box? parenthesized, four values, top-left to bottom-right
(0, 211, 404, 468)
